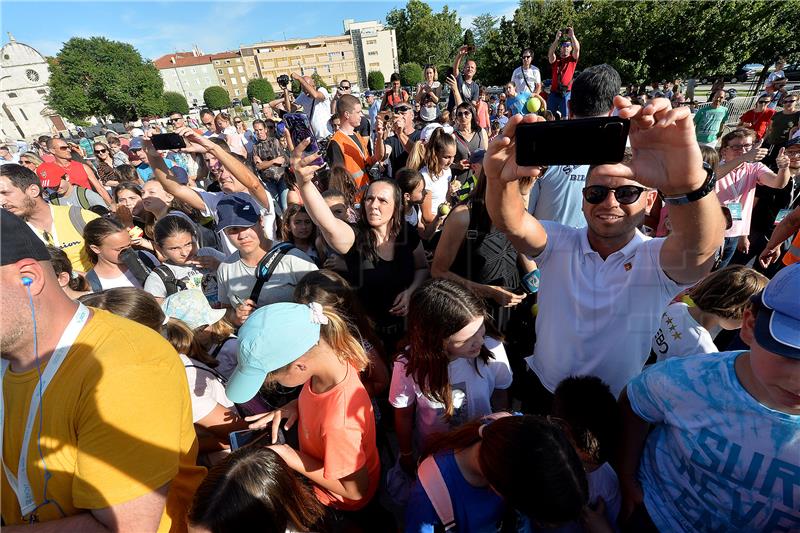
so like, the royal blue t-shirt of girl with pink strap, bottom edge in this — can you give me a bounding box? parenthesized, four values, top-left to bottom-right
(406, 450, 504, 533)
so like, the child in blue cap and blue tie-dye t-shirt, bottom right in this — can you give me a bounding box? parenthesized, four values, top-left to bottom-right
(619, 264, 800, 532)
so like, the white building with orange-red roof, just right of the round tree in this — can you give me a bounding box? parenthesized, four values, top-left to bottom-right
(153, 47, 216, 107)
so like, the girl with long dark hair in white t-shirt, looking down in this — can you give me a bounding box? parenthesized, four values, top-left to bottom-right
(389, 279, 512, 471)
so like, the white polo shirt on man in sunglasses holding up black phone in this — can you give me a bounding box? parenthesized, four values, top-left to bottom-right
(526, 220, 685, 396)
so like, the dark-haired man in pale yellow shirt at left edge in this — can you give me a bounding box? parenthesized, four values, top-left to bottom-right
(0, 164, 98, 272)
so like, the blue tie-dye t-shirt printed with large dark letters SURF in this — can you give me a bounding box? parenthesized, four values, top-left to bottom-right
(627, 352, 800, 532)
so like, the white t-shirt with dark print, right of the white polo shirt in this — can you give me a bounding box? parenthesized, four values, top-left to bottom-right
(652, 302, 718, 362)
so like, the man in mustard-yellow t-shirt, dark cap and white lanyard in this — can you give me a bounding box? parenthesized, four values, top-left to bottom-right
(0, 210, 205, 533)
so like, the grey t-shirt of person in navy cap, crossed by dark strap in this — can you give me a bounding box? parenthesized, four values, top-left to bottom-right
(217, 248, 317, 307)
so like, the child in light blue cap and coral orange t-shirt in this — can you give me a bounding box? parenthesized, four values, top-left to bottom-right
(226, 303, 380, 511)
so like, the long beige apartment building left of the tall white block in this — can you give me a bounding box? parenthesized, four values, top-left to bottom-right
(240, 35, 361, 91)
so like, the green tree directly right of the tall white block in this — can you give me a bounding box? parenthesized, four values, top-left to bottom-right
(386, 0, 462, 64)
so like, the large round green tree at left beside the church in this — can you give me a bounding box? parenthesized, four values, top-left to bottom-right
(46, 37, 164, 121)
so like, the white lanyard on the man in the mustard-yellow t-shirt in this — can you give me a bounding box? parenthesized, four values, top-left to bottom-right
(0, 304, 89, 516)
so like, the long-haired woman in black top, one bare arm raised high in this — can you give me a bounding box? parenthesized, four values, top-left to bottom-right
(291, 140, 428, 351)
